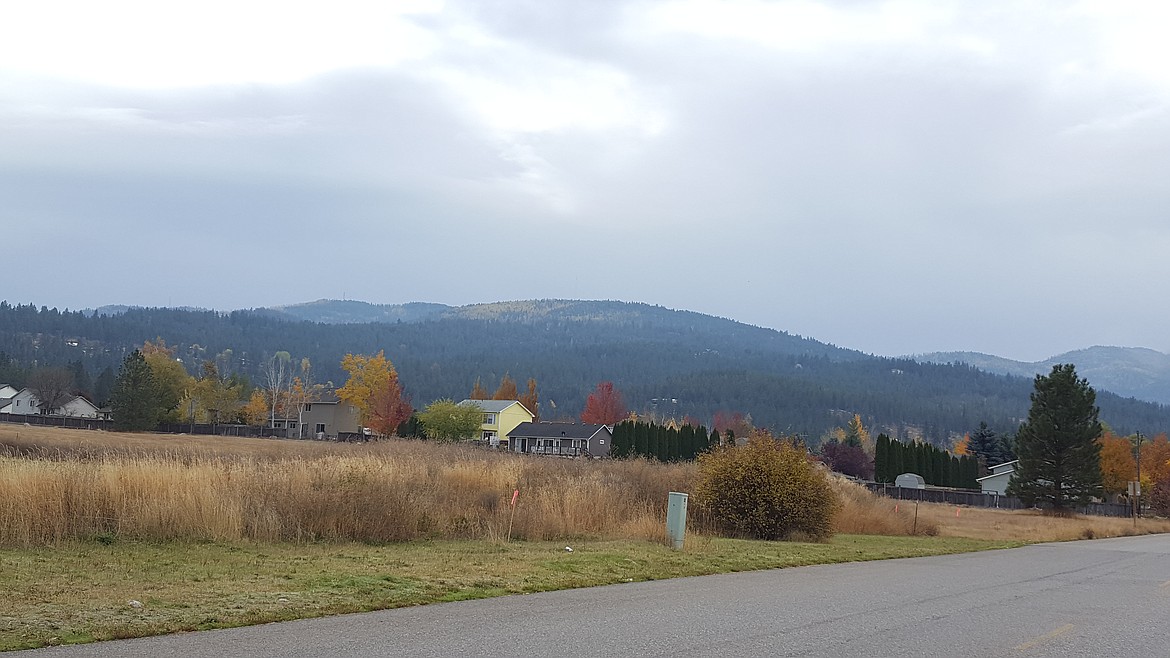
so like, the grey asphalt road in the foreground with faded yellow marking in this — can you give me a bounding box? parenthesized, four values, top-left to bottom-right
(20, 535, 1170, 658)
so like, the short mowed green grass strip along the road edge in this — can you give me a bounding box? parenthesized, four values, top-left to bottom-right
(0, 535, 1019, 651)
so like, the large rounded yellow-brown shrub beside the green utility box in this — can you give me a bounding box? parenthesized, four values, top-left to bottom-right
(695, 434, 839, 540)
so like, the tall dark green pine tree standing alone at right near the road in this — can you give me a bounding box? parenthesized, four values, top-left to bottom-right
(1007, 364, 1102, 515)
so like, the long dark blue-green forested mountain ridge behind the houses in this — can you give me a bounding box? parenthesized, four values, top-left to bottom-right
(0, 300, 1170, 444)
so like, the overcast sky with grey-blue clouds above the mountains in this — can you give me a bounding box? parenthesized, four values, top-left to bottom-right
(0, 0, 1170, 361)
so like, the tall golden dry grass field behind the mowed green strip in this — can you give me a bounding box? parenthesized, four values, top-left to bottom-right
(0, 424, 1170, 547)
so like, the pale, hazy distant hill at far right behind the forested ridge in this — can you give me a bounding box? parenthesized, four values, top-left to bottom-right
(914, 345, 1170, 405)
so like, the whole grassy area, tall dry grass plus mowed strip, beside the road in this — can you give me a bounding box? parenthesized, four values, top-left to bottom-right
(0, 424, 1170, 651)
